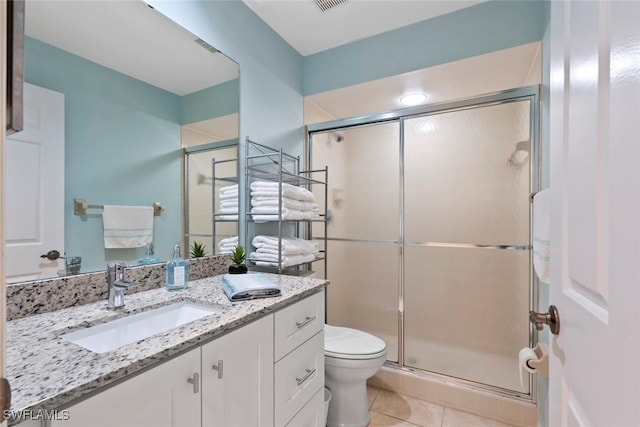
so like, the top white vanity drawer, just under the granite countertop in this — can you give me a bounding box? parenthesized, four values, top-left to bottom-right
(274, 291, 324, 361)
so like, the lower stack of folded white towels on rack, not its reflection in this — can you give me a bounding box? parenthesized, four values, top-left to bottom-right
(249, 236, 319, 268)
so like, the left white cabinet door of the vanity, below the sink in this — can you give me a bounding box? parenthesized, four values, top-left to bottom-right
(51, 348, 200, 427)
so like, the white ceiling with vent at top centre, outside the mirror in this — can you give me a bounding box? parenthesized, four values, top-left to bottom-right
(242, 0, 486, 56)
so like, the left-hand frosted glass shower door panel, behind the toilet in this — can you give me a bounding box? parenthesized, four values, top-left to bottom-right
(311, 121, 400, 362)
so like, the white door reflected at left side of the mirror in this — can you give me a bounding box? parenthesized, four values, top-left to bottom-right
(4, 83, 65, 283)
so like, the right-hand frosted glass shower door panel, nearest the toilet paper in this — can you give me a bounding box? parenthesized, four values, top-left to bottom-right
(403, 100, 532, 393)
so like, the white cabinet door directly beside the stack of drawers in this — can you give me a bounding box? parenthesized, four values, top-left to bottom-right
(202, 315, 273, 427)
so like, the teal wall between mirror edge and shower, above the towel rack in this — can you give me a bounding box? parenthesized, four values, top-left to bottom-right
(148, 0, 304, 242)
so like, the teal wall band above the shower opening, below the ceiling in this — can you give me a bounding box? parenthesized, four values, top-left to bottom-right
(303, 0, 549, 95)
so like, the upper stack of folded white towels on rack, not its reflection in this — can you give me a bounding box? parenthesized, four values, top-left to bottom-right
(251, 181, 319, 222)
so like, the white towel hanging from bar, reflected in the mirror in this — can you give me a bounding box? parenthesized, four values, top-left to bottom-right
(102, 205, 153, 249)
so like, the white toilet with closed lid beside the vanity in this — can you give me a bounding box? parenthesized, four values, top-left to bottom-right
(324, 325, 387, 427)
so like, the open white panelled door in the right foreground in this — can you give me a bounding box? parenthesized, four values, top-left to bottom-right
(542, 1, 640, 427)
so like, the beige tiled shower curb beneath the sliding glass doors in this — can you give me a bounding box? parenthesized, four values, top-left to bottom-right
(369, 367, 537, 427)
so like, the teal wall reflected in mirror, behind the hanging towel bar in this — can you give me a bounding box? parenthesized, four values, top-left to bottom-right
(25, 38, 182, 271)
